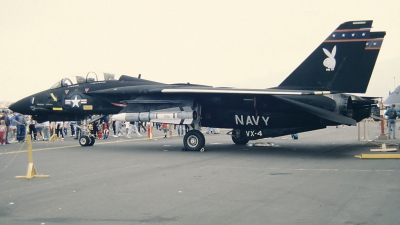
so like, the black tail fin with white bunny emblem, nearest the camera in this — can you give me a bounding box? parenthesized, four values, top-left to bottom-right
(277, 20, 376, 92)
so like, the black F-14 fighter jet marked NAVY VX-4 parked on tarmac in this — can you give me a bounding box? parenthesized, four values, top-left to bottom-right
(10, 20, 386, 150)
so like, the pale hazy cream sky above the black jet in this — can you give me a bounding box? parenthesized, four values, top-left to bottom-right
(0, 0, 400, 101)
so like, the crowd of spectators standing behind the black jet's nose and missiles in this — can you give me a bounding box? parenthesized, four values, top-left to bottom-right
(0, 110, 222, 145)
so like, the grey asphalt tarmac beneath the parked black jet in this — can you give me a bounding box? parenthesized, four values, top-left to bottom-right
(0, 124, 400, 225)
